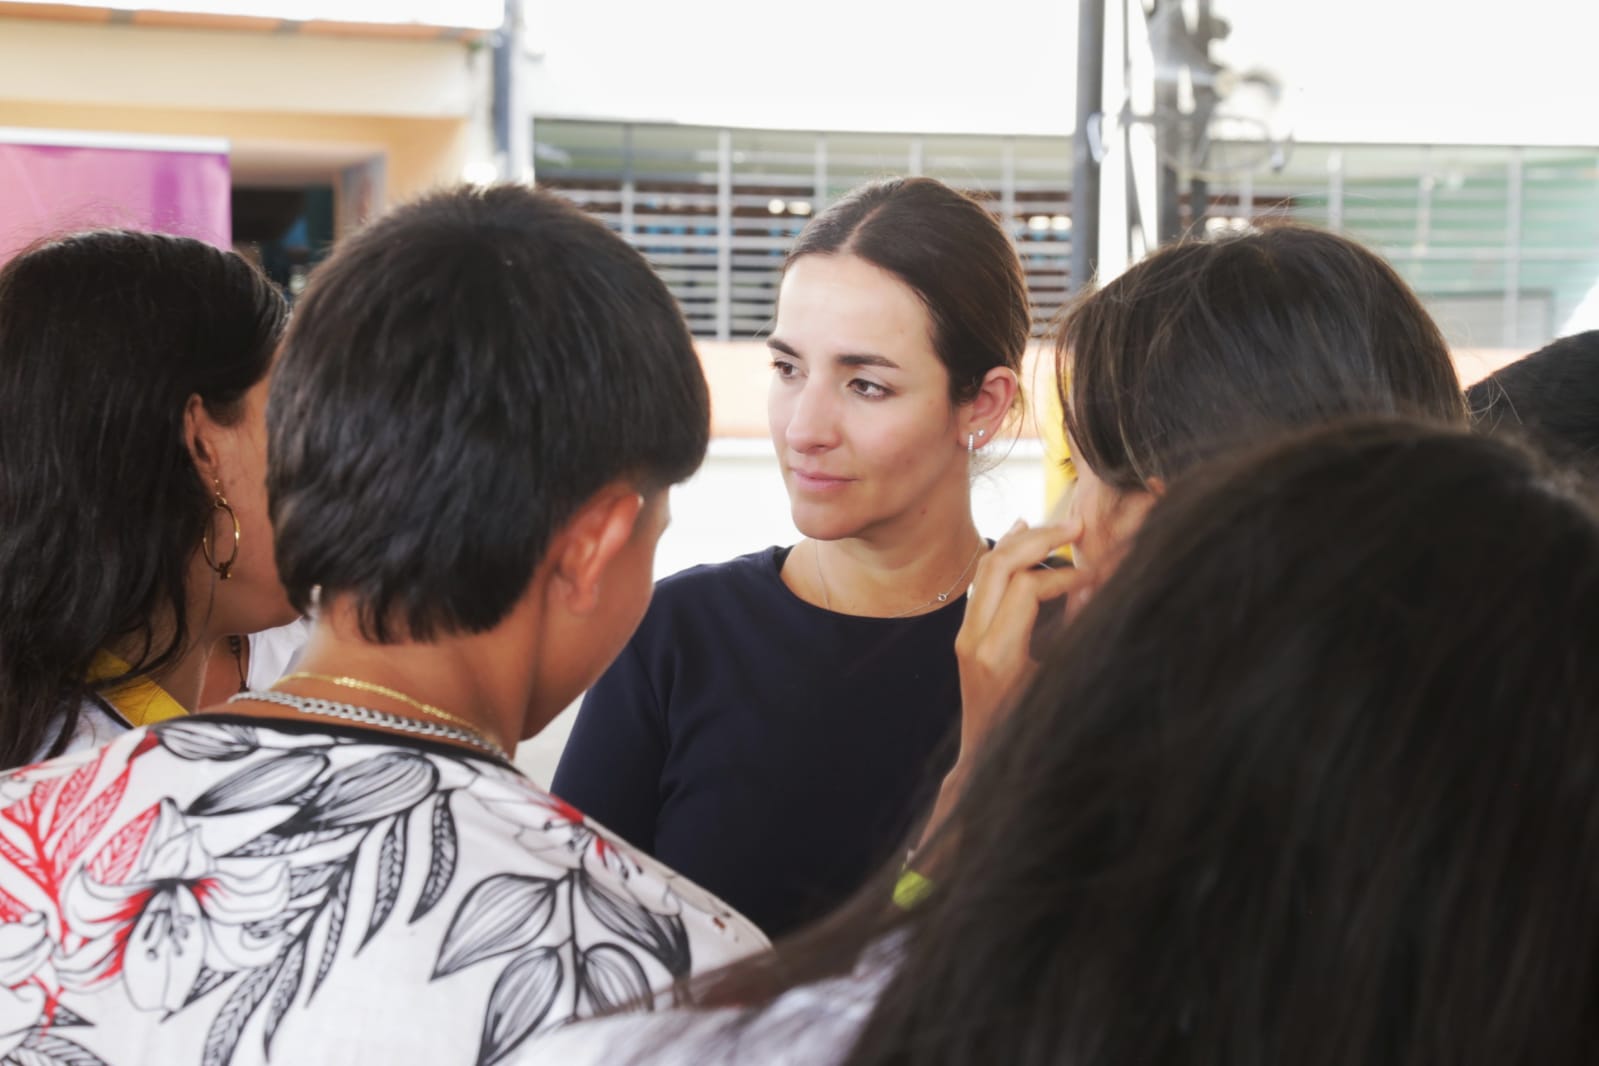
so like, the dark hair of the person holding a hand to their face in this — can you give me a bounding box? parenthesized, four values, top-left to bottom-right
(1059, 225, 1465, 489)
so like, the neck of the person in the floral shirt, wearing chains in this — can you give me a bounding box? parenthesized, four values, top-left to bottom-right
(217, 606, 534, 754)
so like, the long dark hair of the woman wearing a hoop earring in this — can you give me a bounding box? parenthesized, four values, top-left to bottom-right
(0, 230, 288, 766)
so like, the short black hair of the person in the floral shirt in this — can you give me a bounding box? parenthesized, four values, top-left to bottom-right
(267, 185, 710, 641)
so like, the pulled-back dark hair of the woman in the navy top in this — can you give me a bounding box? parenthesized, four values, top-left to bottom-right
(785, 177, 1033, 403)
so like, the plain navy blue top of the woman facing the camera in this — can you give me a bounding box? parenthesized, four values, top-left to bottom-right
(552, 548, 966, 937)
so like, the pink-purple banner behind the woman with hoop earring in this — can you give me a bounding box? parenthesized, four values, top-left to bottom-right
(0, 129, 232, 262)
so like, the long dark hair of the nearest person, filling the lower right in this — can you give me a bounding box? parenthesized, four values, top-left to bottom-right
(693, 422, 1599, 1066)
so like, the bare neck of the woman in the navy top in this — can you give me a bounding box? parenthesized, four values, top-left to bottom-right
(811, 511, 985, 617)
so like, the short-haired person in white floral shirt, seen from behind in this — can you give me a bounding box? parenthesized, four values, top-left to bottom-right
(0, 185, 764, 1064)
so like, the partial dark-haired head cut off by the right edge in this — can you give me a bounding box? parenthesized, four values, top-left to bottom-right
(1466, 329, 1599, 473)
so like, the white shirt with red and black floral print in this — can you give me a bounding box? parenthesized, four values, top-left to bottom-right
(0, 714, 766, 1066)
